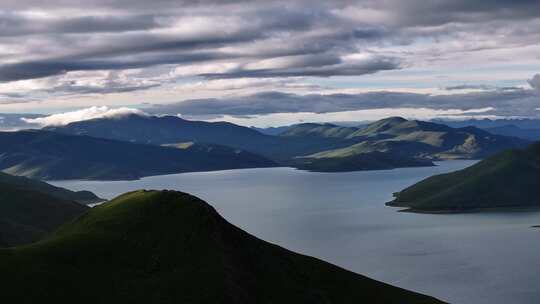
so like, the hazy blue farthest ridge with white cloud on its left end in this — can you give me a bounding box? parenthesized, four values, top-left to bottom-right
(47, 115, 354, 161)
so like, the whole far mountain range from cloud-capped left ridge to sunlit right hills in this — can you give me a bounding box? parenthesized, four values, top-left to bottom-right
(48, 115, 528, 172)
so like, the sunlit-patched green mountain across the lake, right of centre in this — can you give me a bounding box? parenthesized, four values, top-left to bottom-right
(302, 117, 529, 160)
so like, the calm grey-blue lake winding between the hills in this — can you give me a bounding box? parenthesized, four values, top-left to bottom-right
(52, 161, 540, 304)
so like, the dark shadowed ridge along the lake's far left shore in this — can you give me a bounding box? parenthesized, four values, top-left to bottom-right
(0, 130, 276, 180)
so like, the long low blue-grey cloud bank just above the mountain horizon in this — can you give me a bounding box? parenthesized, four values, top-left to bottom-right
(148, 89, 540, 116)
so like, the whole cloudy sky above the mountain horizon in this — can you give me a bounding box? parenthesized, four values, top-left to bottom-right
(0, 0, 540, 126)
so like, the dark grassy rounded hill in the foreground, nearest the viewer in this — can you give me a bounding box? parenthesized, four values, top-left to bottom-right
(0, 191, 442, 304)
